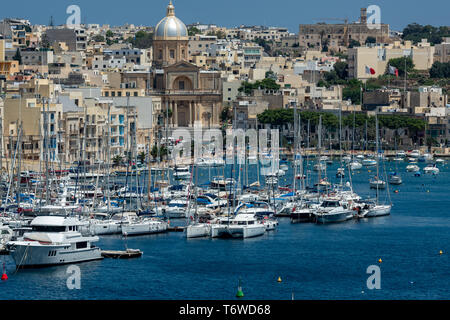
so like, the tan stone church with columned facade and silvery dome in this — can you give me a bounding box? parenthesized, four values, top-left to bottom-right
(151, 1, 222, 128)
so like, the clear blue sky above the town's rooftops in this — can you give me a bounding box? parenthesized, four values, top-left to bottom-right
(0, 0, 450, 32)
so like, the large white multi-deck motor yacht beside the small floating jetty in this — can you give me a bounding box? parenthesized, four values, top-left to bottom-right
(7, 216, 102, 268)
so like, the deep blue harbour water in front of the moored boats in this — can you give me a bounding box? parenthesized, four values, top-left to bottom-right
(0, 162, 450, 300)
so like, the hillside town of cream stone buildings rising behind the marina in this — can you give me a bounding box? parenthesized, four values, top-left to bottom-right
(0, 2, 450, 165)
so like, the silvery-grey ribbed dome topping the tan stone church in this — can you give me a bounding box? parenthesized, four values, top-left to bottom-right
(154, 1, 188, 40)
